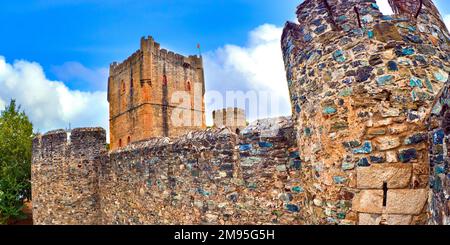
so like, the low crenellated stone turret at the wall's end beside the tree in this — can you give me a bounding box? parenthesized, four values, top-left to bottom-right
(31, 128, 108, 225)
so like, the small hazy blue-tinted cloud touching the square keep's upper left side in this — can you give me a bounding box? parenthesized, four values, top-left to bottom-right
(51, 62, 109, 91)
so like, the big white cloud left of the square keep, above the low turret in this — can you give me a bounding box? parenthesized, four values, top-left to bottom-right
(0, 56, 108, 139)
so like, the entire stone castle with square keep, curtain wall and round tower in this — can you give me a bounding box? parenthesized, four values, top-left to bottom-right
(32, 0, 450, 225)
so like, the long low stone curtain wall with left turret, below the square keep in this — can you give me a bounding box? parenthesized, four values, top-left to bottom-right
(32, 118, 303, 224)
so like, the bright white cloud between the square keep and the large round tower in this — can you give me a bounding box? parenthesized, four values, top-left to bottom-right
(204, 24, 291, 123)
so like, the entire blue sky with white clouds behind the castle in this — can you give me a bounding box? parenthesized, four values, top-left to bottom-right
(0, 0, 450, 136)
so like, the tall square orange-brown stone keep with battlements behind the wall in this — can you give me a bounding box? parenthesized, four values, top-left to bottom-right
(108, 37, 206, 150)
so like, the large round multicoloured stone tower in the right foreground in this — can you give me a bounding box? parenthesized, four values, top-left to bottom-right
(282, 0, 450, 224)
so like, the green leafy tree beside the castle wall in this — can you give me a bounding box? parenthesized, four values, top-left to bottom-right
(0, 100, 34, 224)
